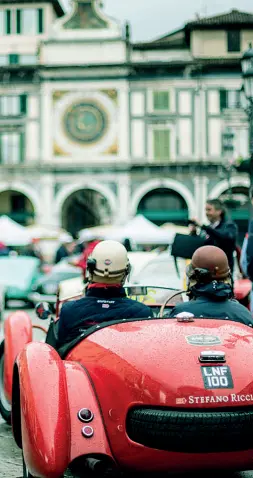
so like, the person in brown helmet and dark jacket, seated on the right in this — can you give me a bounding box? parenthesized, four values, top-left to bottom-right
(166, 246, 253, 327)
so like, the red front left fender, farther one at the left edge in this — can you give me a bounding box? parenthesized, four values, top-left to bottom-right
(4, 311, 32, 401)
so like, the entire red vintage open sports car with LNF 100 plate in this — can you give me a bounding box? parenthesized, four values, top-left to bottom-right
(0, 288, 253, 478)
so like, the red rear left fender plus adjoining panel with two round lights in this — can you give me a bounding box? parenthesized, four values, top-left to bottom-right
(17, 342, 112, 478)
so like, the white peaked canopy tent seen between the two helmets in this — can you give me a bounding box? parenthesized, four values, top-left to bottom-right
(106, 214, 174, 244)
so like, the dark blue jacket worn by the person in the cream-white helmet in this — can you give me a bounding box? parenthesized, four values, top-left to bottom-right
(58, 287, 153, 343)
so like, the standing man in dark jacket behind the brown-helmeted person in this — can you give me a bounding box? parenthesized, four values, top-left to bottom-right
(189, 199, 238, 273)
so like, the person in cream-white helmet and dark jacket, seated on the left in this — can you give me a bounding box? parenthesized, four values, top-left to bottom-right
(58, 241, 153, 344)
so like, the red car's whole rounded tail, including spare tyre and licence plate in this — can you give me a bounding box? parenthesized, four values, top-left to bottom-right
(67, 319, 253, 471)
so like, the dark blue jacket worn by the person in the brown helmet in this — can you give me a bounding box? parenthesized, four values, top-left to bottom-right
(169, 281, 253, 327)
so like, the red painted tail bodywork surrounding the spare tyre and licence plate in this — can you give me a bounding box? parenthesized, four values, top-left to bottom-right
(64, 319, 253, 471)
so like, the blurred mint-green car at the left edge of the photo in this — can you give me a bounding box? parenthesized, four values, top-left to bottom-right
(0, 256, 42, 308)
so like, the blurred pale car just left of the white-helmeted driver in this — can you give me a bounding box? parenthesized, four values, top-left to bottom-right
(29, 258, 82, 305)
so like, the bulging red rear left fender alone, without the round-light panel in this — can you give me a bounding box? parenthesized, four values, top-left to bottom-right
(17, 342, 71, 478)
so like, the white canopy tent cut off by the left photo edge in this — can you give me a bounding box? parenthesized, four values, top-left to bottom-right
(0, 216, 32, 246)
